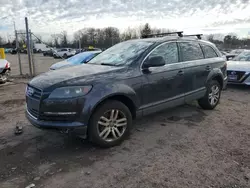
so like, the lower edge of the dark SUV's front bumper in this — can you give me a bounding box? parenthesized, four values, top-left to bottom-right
(25, 110, 87, 136)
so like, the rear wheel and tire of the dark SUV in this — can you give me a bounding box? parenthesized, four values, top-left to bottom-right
(198, 80, 221, 110)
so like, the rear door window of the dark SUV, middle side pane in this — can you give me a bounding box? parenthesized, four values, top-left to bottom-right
(179, 42, 204, 61)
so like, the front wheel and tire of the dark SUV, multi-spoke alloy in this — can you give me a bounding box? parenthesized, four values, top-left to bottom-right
(88, 100, 132, 148)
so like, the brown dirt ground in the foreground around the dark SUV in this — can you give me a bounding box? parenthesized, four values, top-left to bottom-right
(0, 80, 250, 188)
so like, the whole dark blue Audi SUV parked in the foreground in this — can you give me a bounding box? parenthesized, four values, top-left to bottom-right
(26, 33, 227, 147)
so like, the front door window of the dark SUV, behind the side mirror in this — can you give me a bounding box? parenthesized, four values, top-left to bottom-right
(148, 42, 178, 64)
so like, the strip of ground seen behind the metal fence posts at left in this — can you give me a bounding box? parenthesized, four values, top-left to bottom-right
(6, 54, 62, 76)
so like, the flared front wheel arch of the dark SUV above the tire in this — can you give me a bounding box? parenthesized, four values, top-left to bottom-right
(81, 83, 139, 125)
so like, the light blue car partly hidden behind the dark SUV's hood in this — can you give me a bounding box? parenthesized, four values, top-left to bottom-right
(50, 51, 101, 70)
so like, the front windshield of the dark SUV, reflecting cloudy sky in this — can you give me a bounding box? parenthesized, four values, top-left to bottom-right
(88, 40, 153, 66)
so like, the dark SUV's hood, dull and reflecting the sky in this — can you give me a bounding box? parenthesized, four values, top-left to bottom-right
(29, 64, 124, 90)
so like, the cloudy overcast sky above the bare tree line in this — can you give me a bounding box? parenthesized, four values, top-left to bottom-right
(0, 0, 250, 40)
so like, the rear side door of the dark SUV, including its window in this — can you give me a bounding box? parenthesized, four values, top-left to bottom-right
(178, 41, 208, 101)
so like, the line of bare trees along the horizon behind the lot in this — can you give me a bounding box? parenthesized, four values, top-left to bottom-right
(0, 23, 250, 49)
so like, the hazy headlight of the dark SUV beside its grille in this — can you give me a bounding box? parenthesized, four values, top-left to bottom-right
(49, 86, 92, 99)
